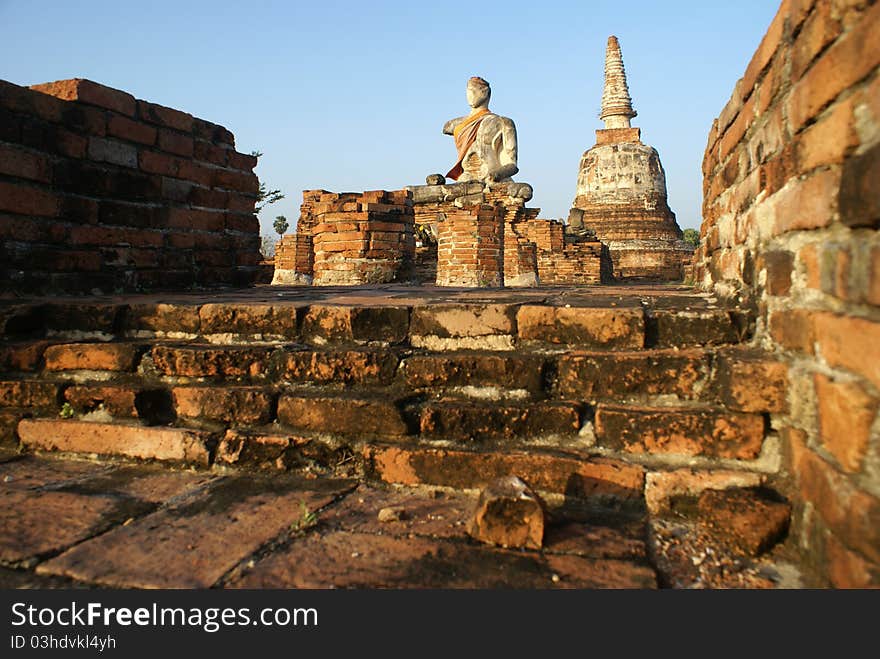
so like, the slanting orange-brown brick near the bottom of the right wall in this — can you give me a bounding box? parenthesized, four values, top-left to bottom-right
(791, 438, 880, 562)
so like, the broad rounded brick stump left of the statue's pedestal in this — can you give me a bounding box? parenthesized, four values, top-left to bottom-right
(310, 190, 415, 285)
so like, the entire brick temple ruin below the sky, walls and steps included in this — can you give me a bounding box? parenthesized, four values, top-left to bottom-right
(0, 0, 880, 589)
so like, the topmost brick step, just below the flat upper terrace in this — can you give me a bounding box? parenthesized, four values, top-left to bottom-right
(0, 296, 748, 351)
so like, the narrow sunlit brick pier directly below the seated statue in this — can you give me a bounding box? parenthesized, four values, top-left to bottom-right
(437, 204, 504, 287)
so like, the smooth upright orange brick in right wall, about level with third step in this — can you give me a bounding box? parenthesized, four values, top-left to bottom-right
(814, 373, 880, 473)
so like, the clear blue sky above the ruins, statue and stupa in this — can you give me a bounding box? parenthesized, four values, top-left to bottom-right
(0, 0, 778, 233)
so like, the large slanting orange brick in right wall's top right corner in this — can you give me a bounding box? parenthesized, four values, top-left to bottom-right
(788, 4, 880, 132)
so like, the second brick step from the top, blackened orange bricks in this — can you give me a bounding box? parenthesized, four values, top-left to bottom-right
(0, 340, 788, 412)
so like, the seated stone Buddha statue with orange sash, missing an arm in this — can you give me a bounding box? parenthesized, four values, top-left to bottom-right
(443, 77, 519, 184)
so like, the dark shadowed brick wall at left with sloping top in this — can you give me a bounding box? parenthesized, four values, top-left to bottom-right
(0, 79, 260, 293)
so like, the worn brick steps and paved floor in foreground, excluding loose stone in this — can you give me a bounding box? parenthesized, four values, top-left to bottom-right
(0, 285, 791, 588)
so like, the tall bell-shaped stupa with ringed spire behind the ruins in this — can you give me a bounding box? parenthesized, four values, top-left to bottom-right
(569, 36, 693, 280)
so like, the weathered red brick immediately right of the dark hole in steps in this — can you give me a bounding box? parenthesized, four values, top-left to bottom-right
(172, 387, 273, 424)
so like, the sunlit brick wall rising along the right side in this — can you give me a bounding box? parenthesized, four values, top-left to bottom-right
(694, 0, 880, 586)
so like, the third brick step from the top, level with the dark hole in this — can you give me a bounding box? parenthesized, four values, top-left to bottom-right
(10, 392, 768, 460)
